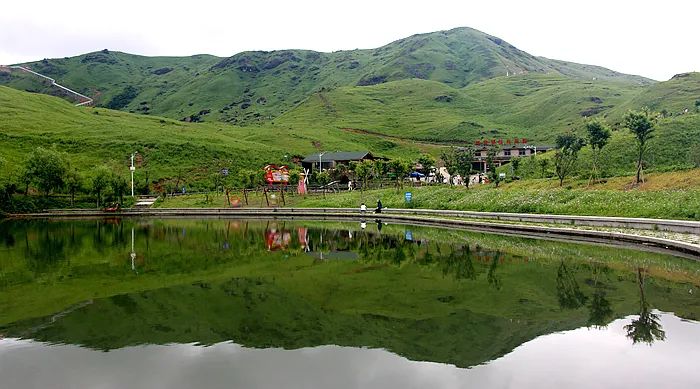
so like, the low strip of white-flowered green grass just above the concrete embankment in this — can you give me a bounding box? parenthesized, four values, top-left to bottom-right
(288, 179, 700, 220)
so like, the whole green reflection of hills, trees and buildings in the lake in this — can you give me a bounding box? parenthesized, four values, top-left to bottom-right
(0, 219, 700, 367)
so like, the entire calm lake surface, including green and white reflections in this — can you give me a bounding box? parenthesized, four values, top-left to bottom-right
(0, 219, 700, 388)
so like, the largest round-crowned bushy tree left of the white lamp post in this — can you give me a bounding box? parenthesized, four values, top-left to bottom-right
(25, 147, 68, 197)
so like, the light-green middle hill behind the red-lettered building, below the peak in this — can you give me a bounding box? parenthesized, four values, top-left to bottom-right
(277, 74, 642, 143)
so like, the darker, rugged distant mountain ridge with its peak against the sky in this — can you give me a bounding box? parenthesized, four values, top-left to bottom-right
(0, 28, 652, 124)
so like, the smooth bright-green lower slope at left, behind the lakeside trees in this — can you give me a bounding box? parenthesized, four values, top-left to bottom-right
(0, 86, 434, 182)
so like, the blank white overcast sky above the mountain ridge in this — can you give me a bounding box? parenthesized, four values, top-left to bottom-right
(0, 0, 700, 80)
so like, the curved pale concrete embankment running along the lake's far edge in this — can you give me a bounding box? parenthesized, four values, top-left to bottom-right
(9, 208, 700, 260)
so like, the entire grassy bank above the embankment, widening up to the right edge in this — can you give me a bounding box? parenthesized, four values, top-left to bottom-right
(157, 169, 700, 220)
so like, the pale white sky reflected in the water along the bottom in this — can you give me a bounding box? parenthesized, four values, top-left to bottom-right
(0, 312, 700, 389)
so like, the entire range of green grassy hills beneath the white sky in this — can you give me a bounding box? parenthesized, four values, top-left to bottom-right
(0, 28, 700, 181)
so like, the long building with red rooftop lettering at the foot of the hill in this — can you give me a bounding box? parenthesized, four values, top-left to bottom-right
(472, 138, 554, 172)
